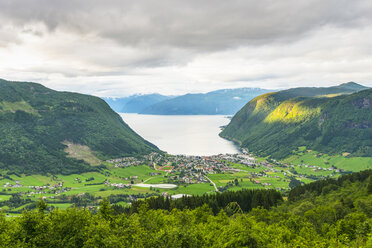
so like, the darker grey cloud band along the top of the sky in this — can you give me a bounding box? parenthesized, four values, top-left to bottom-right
(0, 0, 372, 51)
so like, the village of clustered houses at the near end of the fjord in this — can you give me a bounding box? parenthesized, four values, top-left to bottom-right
(107, 150, 343, 190)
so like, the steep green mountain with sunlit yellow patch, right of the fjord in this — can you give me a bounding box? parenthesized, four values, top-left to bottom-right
(220, 83, 372, 158)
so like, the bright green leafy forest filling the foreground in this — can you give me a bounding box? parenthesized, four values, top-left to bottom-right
(0, 171, 372, 248)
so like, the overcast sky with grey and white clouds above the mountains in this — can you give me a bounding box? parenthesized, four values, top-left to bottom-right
(0, 0, 372, 97)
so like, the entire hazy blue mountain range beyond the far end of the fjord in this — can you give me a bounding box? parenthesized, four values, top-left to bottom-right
(104, 88, 270, 115)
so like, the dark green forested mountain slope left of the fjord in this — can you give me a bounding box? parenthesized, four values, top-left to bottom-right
(0, 80, 157, 174)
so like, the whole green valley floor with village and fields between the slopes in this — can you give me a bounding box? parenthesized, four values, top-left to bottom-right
(0, 147, 372, 214)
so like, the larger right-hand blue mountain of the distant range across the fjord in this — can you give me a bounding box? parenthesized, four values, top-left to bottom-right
(140, 88, 269, 115)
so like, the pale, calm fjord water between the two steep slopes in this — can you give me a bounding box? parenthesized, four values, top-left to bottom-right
(120, 113, 239, 156)
